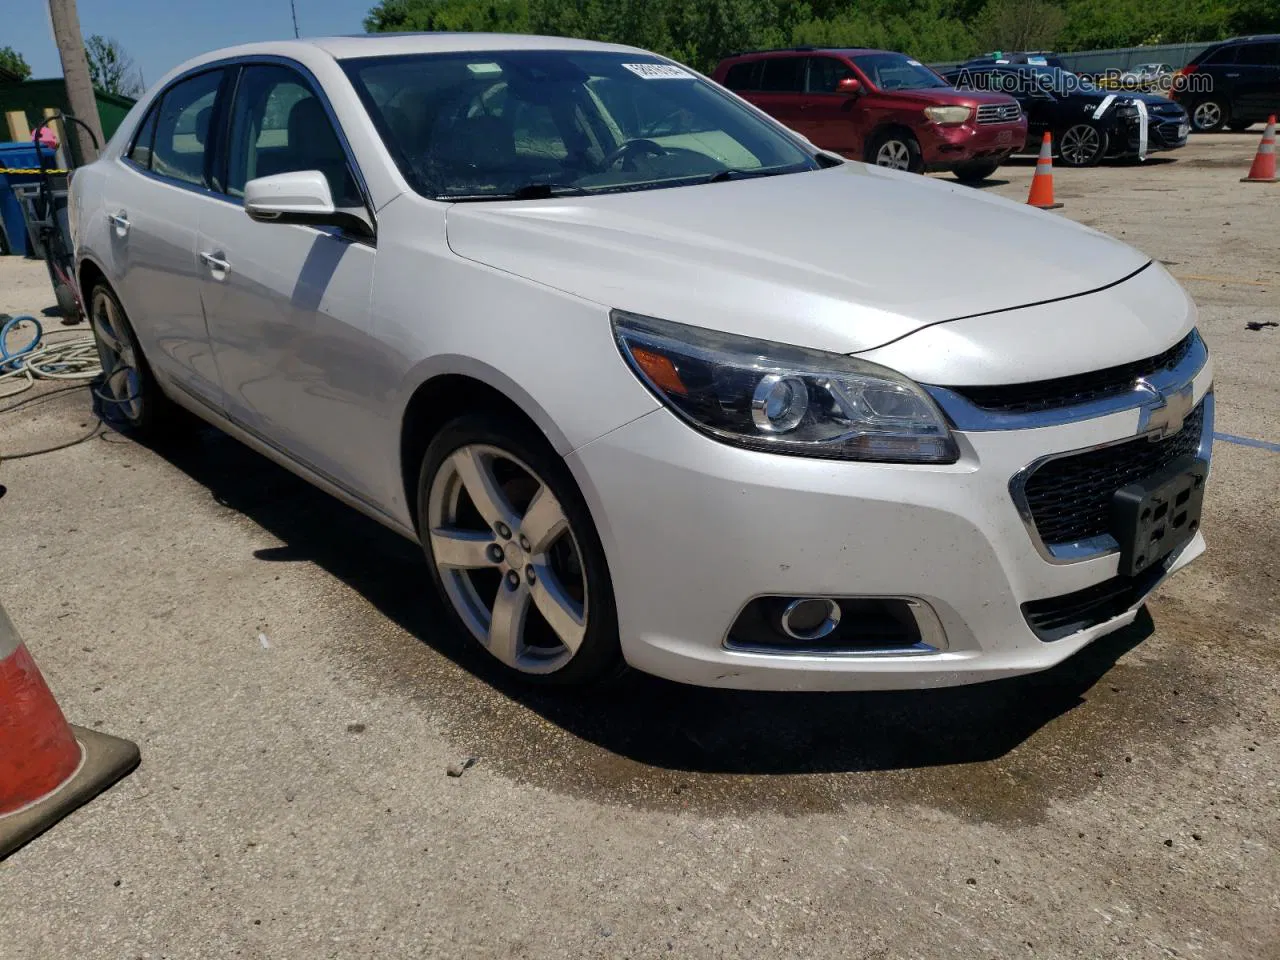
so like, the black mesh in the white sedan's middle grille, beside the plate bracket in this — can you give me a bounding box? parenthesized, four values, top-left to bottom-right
(1023, 402, 1204, 544)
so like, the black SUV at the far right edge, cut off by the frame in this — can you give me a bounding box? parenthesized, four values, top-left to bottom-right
(1174, 33, 1280, 132)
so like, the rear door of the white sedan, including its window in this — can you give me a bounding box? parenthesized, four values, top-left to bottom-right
(104, 68, 228, 408)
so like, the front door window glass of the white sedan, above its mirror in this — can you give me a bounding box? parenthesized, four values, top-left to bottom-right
(227, 64, 364, 207)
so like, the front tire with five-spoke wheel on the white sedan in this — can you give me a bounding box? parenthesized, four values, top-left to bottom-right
(417, 413, 625, 687)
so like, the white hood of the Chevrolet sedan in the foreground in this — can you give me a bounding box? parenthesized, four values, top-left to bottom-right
(447, 163, 1148, 353)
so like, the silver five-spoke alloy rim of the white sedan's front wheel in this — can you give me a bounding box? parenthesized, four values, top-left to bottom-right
(426, 444, 588, 673)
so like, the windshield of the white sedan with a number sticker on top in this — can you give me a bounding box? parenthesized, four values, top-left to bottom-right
(342, 50, 819, 200)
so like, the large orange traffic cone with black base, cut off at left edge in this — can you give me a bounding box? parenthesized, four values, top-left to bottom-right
(0, 607, 140, 859)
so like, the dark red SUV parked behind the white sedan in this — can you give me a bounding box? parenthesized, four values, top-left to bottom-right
(713, 47, 1027, 182)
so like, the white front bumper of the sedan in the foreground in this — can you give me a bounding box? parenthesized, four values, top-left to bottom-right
(567, 367, 1212, 690)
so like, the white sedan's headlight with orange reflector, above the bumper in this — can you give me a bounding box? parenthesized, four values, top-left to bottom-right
(612, 310, 960, 463)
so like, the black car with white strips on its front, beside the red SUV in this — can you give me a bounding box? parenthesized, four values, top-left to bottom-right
(942, 64, 1190, 166)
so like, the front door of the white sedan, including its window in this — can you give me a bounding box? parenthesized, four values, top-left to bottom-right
(197, 64, 378, 495)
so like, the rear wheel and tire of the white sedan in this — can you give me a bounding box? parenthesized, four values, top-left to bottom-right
(87, 283, 191, 440)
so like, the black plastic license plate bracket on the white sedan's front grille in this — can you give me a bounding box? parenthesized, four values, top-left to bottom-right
(1111, 456, 1208, 576)
